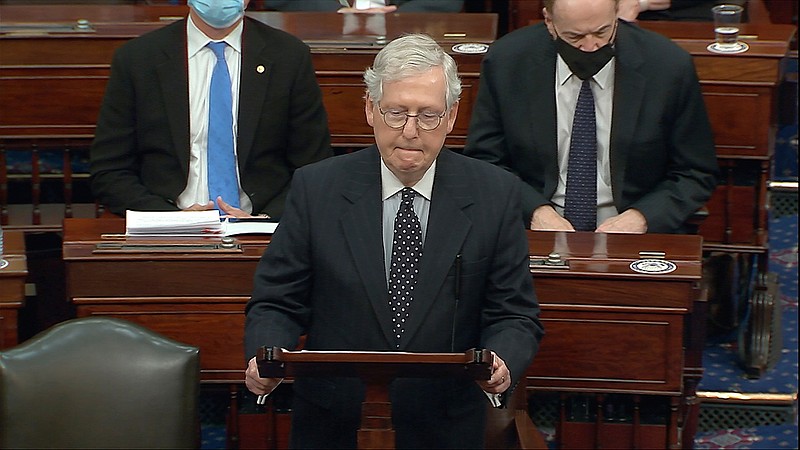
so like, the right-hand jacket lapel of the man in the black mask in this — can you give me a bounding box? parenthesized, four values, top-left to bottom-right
(609, 23, 646, 207)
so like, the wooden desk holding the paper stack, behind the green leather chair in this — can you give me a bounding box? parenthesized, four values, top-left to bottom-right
(63, 219, 268, 383)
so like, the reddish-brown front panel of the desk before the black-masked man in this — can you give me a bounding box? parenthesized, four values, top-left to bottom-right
(527, 310, 684, 395)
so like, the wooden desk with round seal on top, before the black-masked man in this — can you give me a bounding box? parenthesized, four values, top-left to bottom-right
(527, 232, 705, 448)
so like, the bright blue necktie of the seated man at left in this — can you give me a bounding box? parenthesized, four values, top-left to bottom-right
(208, 42, 239, 208)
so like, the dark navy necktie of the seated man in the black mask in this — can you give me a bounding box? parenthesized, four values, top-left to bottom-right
(564, 79, 597, 231)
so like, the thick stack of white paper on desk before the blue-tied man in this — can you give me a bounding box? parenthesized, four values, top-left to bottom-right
(125, 210, 224, 236)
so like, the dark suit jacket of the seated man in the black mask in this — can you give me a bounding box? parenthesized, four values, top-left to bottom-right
(464, 21, 718, 233)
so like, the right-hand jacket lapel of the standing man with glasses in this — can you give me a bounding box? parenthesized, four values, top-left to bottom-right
(400, 149, 473, 343)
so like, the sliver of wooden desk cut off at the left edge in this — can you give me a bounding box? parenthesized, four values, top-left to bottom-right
(0, 230, 28, 350)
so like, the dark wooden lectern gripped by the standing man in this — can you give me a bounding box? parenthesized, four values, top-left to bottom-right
(256, 347, 493, 449)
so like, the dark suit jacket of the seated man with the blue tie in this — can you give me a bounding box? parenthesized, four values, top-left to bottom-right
(91, 17, 332, 217)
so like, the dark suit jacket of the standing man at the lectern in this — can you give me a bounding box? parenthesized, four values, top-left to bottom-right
(245, 146, 543, 448)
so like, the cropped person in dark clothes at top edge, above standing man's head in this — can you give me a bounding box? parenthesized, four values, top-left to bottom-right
(261, 0, 464, 14)
